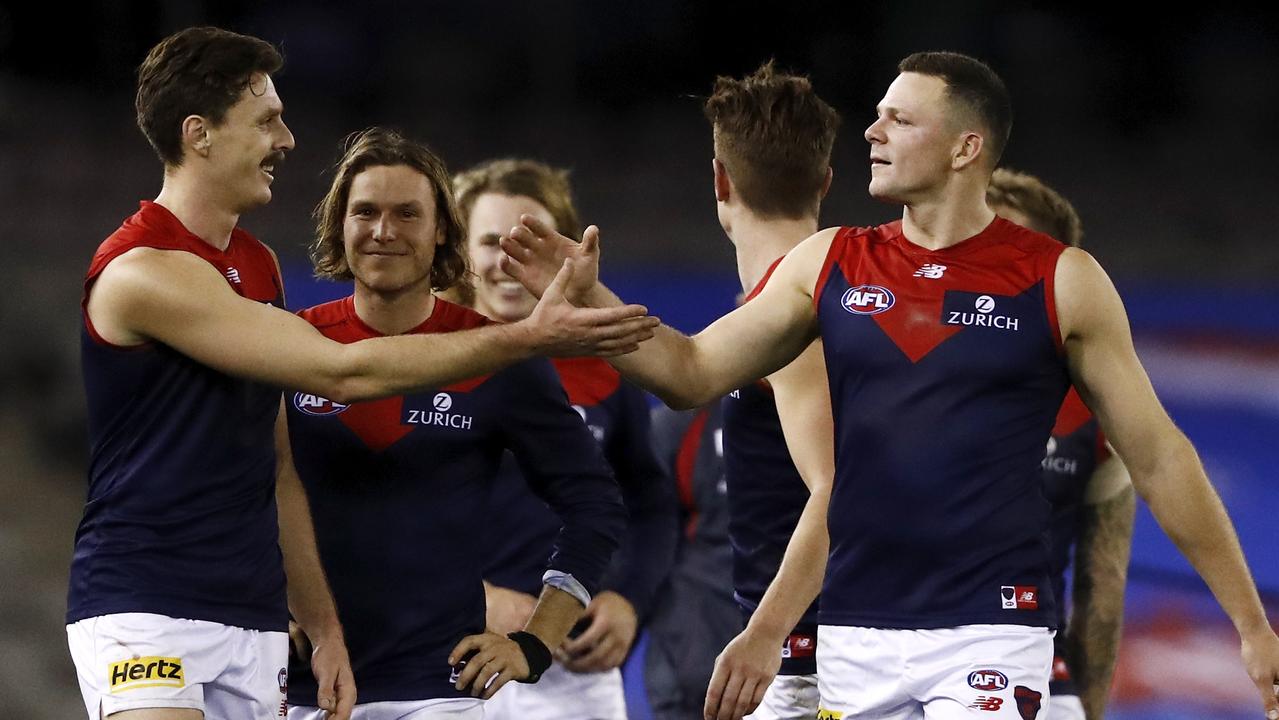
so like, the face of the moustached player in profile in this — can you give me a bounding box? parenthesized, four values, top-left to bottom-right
(207, 73, 293, 212)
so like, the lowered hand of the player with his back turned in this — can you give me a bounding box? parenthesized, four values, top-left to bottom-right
(702, 628, 783, 720)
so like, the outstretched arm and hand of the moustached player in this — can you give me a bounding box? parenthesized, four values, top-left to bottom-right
(87, 248, 655, 403)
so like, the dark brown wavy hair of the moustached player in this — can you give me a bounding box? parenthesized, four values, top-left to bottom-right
(134, 27, 284, 166)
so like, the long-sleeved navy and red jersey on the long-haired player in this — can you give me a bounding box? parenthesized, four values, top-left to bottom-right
(286, 297, 625, 705)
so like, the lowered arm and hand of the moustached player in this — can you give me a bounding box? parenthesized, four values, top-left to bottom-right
(275, 407, 356, 719)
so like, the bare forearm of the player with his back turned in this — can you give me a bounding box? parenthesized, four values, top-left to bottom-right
(747, 486, 830, 647)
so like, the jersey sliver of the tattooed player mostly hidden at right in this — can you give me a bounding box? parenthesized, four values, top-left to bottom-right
(1044, 387, 1110, 694)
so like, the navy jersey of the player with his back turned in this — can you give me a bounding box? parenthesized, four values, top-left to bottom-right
(723, 258, 817, 675)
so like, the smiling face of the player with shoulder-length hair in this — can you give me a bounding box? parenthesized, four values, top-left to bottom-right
(343, 165, 444, 295)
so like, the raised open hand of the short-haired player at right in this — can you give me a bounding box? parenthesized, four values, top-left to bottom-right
(499, 215, 600, 304)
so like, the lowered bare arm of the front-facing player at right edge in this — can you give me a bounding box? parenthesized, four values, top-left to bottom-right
(1055, 248, 1279, 717)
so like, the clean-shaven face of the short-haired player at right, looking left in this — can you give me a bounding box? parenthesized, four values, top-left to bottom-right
(866, 73, 963, 205)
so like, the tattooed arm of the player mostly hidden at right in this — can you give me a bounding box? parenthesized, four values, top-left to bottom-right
(1065, 455, 1137, 720)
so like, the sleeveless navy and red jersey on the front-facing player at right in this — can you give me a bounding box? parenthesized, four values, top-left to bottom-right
(813, 217, 1069, 628)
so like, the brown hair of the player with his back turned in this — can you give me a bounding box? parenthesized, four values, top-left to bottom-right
(703, 60, 840, 217)
